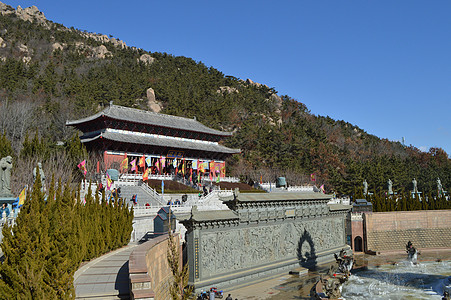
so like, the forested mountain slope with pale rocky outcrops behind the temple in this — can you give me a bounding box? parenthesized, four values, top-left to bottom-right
(0, 3, 451, 194)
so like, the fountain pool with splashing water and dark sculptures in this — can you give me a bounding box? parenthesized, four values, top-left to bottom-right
(310, 241, 451, 300)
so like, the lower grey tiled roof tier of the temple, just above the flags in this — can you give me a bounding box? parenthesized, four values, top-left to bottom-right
(80, 131, 241, 154)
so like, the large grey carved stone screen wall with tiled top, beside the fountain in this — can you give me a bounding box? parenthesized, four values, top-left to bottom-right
(182, 193, 349, 290)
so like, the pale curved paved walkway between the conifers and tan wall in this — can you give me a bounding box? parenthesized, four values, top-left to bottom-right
(74, 245, 136, 300)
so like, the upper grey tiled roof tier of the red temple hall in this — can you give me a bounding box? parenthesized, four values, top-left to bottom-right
(66, 105, 232, 136)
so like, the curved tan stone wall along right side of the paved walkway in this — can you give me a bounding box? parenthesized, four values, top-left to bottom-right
(129, 234, 182, 300)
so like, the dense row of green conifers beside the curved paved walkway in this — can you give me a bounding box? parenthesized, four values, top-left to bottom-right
(0, 172, 133, 299)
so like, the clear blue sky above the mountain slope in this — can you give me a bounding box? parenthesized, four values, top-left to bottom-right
(4, 0, 451, 154)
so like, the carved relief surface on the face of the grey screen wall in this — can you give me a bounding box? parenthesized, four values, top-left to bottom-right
(199, 217, 345, 278)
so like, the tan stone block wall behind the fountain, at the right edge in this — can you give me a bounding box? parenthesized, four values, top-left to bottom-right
(364, 210, 451, 252)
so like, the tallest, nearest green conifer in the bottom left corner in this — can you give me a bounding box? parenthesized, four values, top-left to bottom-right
(0, 172, 57, 299)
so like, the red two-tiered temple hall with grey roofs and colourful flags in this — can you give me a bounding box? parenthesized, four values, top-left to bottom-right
(66, 104, 240, 177)
